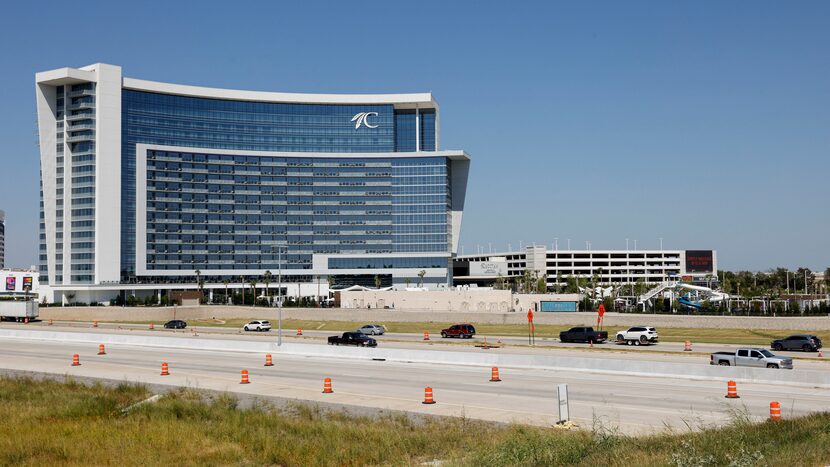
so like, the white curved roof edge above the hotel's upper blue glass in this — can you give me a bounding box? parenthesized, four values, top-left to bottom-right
(123, 77, 438, 108)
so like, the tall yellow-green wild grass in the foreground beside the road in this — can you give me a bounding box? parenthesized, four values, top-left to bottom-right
(0, 377, 830, 466)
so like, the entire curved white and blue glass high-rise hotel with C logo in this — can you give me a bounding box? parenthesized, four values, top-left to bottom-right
(36, 63, 470, 302)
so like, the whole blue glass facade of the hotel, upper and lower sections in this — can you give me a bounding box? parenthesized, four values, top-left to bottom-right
(123, 89, 442, 279)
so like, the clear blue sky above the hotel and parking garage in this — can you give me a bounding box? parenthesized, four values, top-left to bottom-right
(0, 0, 830, 270)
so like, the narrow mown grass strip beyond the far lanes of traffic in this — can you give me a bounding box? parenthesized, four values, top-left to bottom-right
(117, 318, 830, 346)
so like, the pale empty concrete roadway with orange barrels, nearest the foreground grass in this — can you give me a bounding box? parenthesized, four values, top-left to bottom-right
(0, 331, 830, 433)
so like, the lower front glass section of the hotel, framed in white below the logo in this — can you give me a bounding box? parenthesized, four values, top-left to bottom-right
(146, 149, 451, 275)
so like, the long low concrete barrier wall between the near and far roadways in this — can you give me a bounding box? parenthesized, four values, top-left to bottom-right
(0, 329, 830, 388)
